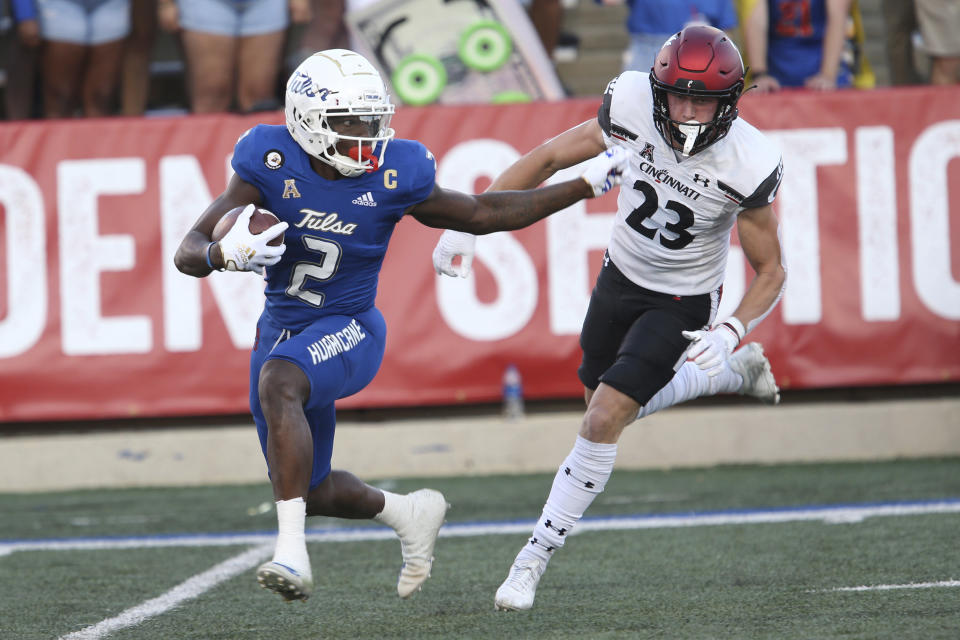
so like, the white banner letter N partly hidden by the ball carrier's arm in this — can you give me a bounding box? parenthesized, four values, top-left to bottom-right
(160, 156, 264, 351)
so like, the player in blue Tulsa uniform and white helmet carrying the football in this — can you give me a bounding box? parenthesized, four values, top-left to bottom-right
(175, 49, 626, 600)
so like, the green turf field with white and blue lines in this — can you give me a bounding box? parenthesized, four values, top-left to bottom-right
(0, 459, 960, 640)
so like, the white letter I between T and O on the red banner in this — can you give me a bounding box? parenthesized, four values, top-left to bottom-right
(855, 127, 900, 322)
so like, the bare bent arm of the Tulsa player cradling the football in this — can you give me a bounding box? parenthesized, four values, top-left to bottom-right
(173, 174, 261, 278)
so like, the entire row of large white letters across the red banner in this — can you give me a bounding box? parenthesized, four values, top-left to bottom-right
(0, 120, 960, 370)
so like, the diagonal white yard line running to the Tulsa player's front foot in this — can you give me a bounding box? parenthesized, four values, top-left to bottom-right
(59, 544, 273, 640)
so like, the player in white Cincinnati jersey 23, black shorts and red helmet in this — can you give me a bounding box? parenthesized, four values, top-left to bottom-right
(434, 25, 786, 610)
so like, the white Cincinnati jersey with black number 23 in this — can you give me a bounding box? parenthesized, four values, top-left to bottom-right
(598, 71, 782, 296)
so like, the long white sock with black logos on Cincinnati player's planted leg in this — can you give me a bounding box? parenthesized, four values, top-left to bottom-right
(517, 436, 617, 563)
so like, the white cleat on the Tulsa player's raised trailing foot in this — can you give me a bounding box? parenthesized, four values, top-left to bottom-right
(397, 489, 450, 598)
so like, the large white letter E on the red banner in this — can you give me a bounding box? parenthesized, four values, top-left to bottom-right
(57, 158, 153, 356)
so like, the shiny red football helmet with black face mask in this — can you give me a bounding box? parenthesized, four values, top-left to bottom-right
(650, 25, 744, 155)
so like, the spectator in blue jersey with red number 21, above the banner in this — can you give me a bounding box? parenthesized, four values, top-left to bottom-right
(741, 0, 873, 93)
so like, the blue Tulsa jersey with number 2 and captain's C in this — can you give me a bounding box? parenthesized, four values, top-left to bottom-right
(233, 125, 436, 330)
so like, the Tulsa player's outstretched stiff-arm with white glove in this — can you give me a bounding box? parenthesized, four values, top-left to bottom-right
(409, 147, 627, 235)
